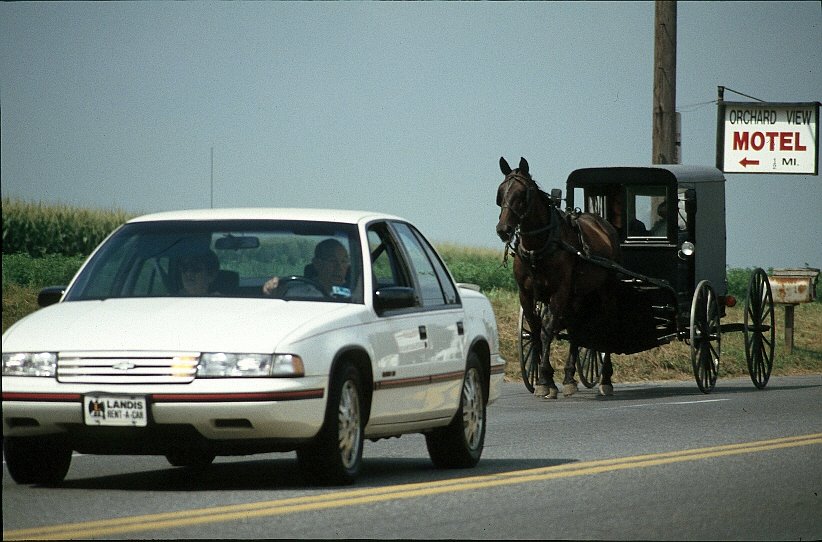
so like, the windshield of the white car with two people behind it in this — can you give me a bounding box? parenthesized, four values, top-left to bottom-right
(65, 220, 363, 303)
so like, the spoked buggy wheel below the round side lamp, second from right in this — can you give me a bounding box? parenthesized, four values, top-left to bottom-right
(691, 280, 722, 393)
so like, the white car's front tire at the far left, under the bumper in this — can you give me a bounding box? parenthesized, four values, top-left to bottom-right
(3, 436, 72, 485)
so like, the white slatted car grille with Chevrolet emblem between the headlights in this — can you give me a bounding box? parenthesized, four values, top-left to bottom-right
(57, 352, 199, 384)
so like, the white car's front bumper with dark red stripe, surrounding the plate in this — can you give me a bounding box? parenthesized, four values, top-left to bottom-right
(2, 377, 326, 441)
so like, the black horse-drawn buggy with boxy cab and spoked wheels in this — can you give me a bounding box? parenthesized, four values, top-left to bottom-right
(519, 165, 774, 393)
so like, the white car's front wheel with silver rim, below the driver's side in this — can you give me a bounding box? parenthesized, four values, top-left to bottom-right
(297, 363, 364, 485)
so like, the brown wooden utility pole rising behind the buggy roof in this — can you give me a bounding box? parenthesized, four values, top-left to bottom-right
(651, 0, 676, 164)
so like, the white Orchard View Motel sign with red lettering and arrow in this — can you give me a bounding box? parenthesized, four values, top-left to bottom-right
(716, 101, 819, 175)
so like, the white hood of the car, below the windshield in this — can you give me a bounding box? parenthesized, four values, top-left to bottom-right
(3, 298, 366, 353)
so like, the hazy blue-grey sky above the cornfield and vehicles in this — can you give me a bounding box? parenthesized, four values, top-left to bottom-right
(0, 1, 822, 268)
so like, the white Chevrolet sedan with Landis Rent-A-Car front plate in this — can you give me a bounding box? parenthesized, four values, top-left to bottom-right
(2, 209, 504, 484)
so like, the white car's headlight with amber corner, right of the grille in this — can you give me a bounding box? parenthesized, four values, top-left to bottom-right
(197, 352, 305, 378)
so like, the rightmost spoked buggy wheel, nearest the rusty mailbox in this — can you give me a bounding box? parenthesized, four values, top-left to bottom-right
(744, 268, 775, 389)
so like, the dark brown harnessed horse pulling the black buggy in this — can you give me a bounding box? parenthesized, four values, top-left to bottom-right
(497, 158, 620, 399)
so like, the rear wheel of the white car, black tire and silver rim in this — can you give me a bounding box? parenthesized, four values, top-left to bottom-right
(425, 352, 486, 469)
